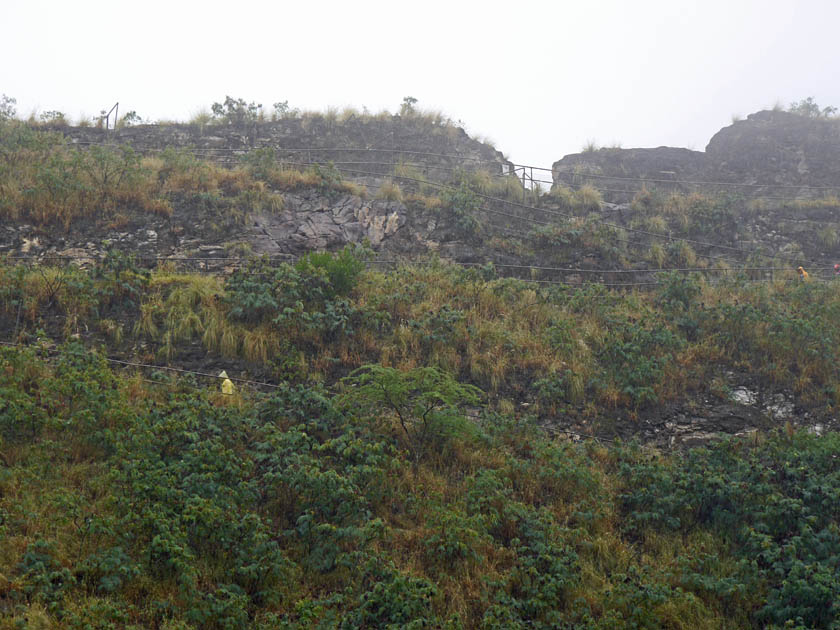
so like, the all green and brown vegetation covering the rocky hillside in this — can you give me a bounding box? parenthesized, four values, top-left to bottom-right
(0, 97, 840, 630)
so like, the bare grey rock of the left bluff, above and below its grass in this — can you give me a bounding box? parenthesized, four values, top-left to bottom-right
(0, 115, 512, 266)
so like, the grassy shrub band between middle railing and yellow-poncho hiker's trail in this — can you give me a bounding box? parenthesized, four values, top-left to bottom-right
(0, 249, 840, 415)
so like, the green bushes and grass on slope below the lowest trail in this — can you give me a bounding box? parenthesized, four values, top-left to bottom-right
(0, 330, 840, 629)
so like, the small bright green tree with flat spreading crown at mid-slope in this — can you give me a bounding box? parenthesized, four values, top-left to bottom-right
(339, 365, 481, 465)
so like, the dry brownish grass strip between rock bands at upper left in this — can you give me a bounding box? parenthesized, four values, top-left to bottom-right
(0, 121, 378, 230)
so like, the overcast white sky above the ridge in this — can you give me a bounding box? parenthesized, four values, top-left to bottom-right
(0, 0, 840, 166)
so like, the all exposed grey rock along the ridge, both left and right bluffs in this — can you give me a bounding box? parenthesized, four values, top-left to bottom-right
(11, 112, 840, 274)
